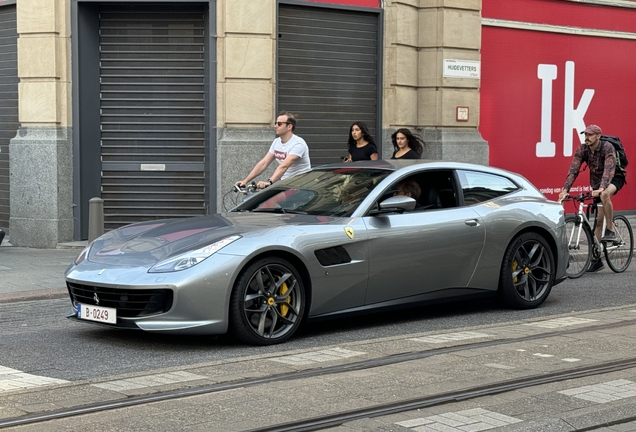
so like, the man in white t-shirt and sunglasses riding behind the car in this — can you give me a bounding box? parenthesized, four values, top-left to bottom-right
(236, 112, 311, 189)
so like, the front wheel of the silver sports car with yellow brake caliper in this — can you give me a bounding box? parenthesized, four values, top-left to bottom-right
(229, 257, 305, 345)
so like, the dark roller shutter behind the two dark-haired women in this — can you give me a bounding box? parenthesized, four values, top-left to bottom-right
(277, 4, 381, 165)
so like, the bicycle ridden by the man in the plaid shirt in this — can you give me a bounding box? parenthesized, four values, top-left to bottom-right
(563, 193, 634, 279)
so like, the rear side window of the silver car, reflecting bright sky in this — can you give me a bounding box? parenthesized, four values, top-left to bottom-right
(457, 170, 519, 205)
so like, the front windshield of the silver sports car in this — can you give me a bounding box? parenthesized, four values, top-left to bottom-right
(232, 167, 391, 217)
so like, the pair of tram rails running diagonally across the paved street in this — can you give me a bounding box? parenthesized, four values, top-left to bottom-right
(0, 320, 636, 432)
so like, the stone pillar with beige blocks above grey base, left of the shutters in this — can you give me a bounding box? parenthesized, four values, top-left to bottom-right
(9, 0, 73, 248)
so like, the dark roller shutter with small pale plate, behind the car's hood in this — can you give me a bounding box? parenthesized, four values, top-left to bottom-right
(99, 3, 209, 230)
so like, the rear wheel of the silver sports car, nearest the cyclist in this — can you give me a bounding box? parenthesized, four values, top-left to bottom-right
(499, 233, 555, 309)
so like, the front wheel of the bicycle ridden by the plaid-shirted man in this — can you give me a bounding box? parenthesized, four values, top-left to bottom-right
(565, 215, 594, 279)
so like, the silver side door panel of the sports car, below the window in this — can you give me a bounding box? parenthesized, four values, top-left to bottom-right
(364, 175, 485, 305)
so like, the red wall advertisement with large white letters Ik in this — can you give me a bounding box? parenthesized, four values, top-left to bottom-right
(480, 0, 636, 210)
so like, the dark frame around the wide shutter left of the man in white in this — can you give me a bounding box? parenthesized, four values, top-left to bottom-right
(71, 0, 217, 240)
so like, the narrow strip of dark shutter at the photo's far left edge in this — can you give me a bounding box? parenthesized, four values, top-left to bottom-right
(0, 5, 20, 227)
